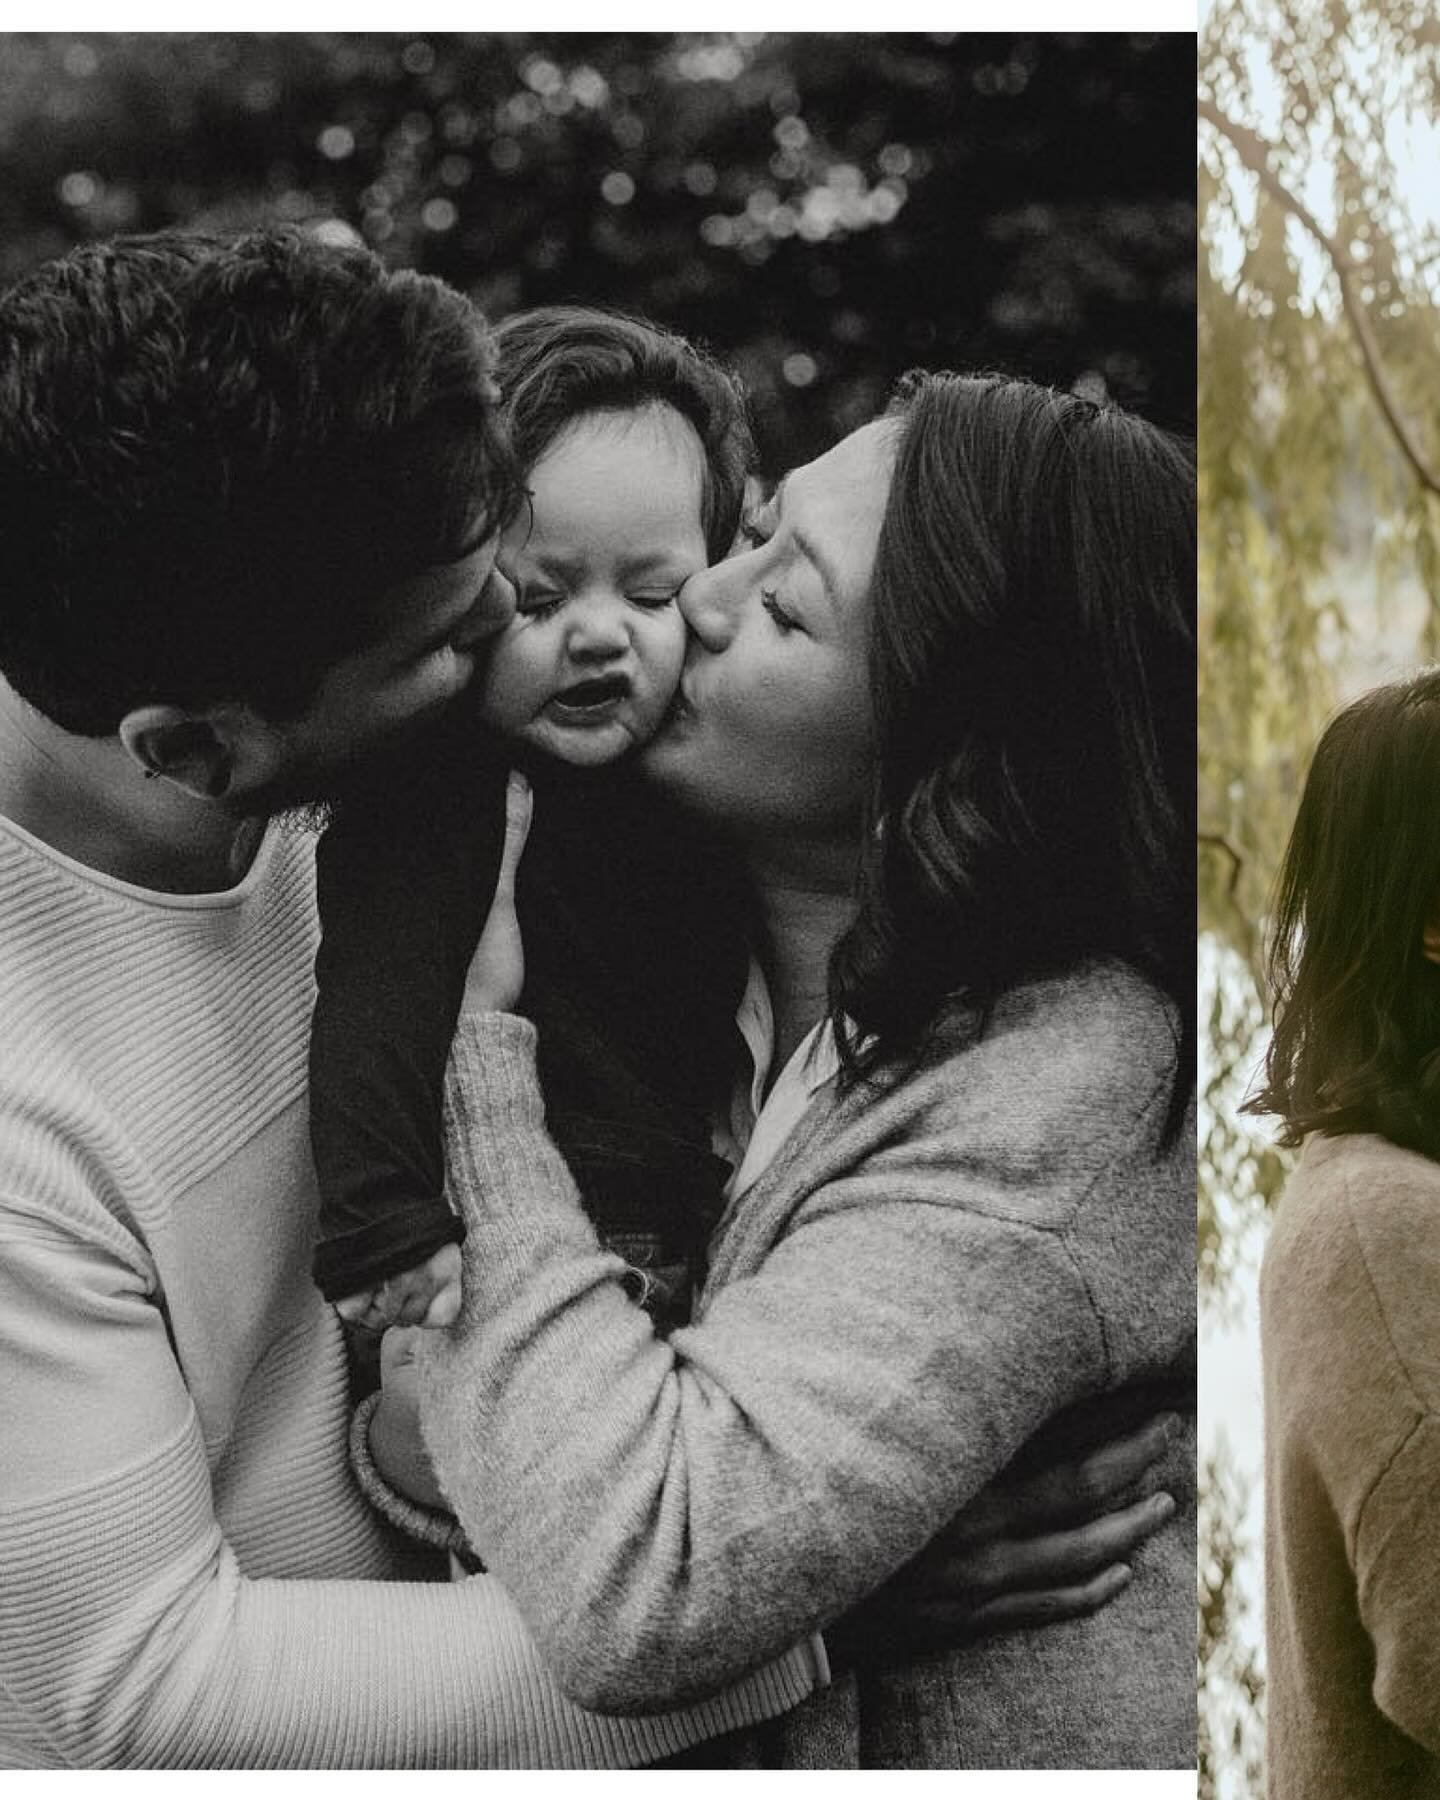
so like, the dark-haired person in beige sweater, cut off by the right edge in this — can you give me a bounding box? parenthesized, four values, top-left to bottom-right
(1246, 670, 1440, 1800)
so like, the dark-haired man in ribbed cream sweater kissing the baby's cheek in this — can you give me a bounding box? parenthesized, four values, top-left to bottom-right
(0, 234, 1166, 1768)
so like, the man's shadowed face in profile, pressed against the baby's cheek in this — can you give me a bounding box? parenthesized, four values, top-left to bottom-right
(241, 536, 515, 814)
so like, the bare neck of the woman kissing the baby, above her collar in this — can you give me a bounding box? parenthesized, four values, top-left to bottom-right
(747, 831, 857, 1080)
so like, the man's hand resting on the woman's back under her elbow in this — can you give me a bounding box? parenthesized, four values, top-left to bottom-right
(824, 1415, 1177, 1665)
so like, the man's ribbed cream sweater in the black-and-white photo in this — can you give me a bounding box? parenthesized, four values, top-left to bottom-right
(0, 819, 815, 1768)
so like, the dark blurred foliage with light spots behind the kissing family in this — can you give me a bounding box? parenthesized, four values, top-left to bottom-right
(0, 32, 1195, 464)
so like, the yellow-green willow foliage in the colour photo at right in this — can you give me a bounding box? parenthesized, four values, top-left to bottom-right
(1199, 0, 1440, 1800)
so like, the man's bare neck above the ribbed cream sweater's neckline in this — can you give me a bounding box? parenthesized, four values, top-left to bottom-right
(0, 679, 261, 893)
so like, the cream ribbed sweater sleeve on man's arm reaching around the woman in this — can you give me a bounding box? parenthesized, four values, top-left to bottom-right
(0, 1199, 814, 1768)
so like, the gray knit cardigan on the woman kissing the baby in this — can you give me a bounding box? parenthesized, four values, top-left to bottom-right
(423, 965, 1195, 1768)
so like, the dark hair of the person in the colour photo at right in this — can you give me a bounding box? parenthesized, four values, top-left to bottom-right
(1244, 670, 1440, 1157)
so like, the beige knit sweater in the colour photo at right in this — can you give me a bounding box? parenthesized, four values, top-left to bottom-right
(1260, 1136, 1440, 1800)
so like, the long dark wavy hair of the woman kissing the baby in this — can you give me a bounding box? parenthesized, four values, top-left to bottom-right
(830, 373, 1195, 1138)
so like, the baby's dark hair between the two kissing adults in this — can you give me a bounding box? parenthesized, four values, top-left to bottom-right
(495, 306, 754, 562)
